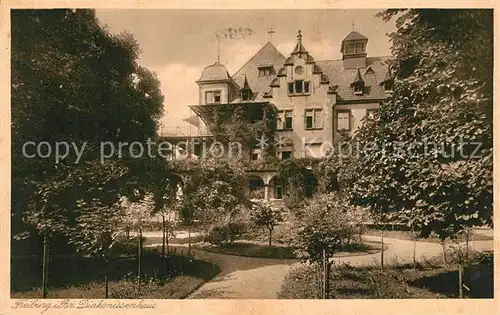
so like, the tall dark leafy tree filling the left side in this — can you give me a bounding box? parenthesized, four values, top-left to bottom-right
(11, 9, 163, 295)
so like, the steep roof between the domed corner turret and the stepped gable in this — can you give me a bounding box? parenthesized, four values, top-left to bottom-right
(233, 42, 285, 100)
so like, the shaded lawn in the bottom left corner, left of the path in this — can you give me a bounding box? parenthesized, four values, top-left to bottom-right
(11, 252, 220, 299)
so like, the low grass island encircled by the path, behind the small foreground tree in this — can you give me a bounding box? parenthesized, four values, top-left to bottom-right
(193, 241, 381, 259)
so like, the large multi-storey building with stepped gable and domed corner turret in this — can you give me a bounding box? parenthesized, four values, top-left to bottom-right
(161, 31, 393, 199)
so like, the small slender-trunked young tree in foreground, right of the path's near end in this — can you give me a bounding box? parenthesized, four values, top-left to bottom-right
(294, 193, 355, 298)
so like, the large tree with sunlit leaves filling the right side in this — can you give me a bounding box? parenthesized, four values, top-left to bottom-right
(351, 9, 493, 262)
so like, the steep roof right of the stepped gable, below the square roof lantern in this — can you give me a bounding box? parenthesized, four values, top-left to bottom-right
(316, 57, 391, 103)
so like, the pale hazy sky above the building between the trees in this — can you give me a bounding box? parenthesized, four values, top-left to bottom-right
(97, 9, 396, 129)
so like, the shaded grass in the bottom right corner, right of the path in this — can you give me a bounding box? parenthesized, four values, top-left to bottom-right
(279, 253, 493, 299)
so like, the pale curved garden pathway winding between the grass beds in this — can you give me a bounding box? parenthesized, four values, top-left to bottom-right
(144, 236, 493, 299)
